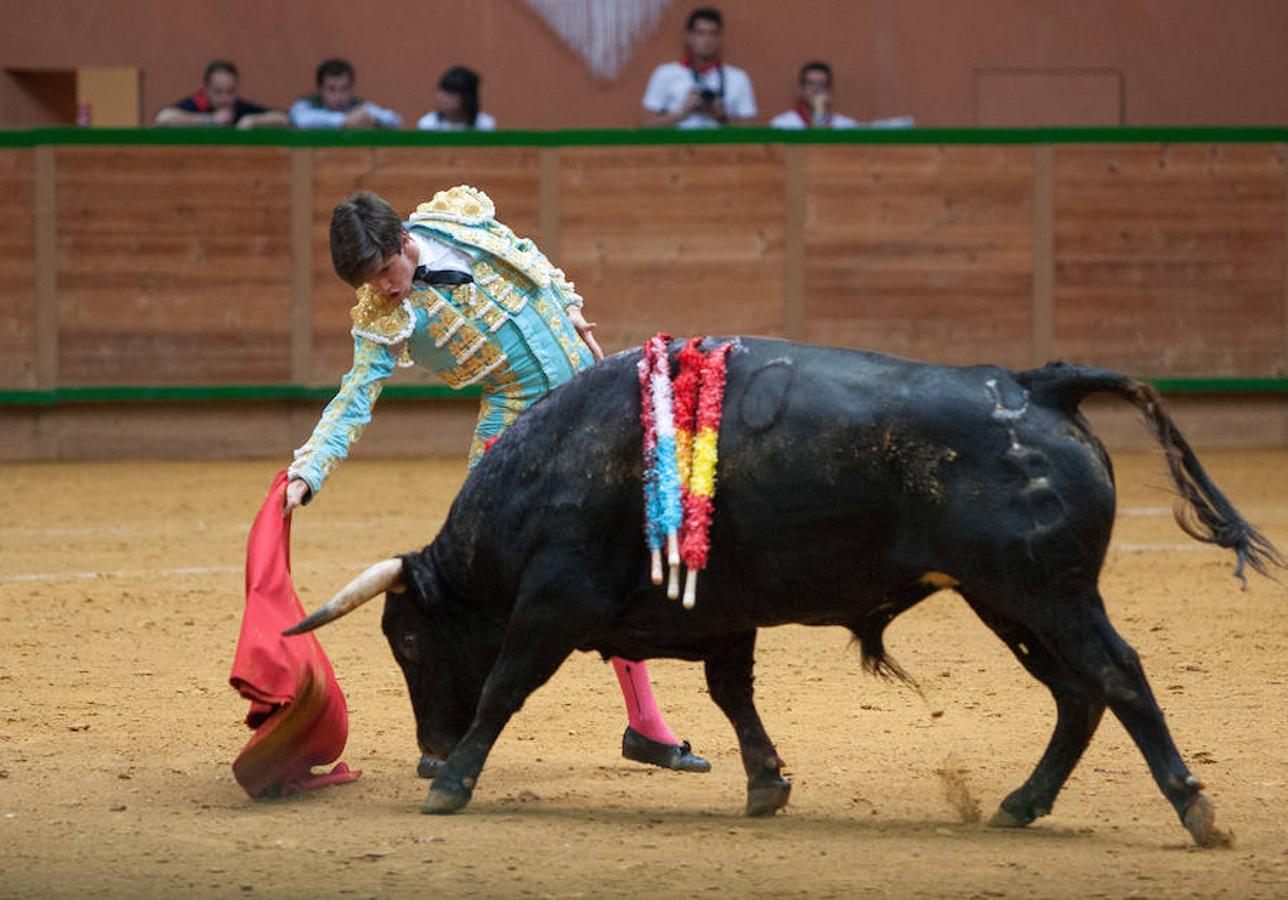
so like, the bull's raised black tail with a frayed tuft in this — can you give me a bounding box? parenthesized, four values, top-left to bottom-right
(1016, 363, 1284, 587)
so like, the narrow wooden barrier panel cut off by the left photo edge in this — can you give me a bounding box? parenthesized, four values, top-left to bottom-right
(0, 149, 44, 389)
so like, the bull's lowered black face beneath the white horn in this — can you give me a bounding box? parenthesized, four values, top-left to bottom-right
(380, 588, 482, 760)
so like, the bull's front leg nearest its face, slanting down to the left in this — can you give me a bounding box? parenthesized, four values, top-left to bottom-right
(420, 617, 576, 814)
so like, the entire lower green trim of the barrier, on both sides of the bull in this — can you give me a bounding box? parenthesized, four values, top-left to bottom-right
(0, 379, 1288, 407)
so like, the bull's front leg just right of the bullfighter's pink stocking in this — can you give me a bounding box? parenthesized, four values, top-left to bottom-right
(706, 631, 792, 815)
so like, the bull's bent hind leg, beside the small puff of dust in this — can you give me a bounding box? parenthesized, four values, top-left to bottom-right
(971, 601, 1105, 828)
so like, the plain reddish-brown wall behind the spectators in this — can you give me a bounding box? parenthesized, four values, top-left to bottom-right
(0, 0, 1288, 127)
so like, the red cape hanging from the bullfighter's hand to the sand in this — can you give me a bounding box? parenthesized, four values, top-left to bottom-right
(228, 470, 362, 797)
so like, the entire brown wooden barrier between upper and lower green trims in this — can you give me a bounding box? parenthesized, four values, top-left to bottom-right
(0, 133, 1288, 401)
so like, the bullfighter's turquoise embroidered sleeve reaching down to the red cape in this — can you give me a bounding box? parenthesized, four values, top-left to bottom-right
(287, 337, 397, 494)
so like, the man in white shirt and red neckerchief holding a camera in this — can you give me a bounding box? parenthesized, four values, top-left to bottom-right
(641, 6, 756, 129)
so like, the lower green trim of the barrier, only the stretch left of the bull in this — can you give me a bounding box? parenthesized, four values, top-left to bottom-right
(0, 385, 483, 407)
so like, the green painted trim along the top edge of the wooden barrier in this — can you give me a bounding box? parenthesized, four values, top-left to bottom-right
(0, 125, 1288, 148)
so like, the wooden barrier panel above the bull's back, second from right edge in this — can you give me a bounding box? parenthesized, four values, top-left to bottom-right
(805, 145, 1033, 366)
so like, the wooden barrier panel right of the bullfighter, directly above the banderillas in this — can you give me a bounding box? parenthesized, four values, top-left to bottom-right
(559, 144, 786, 353)
